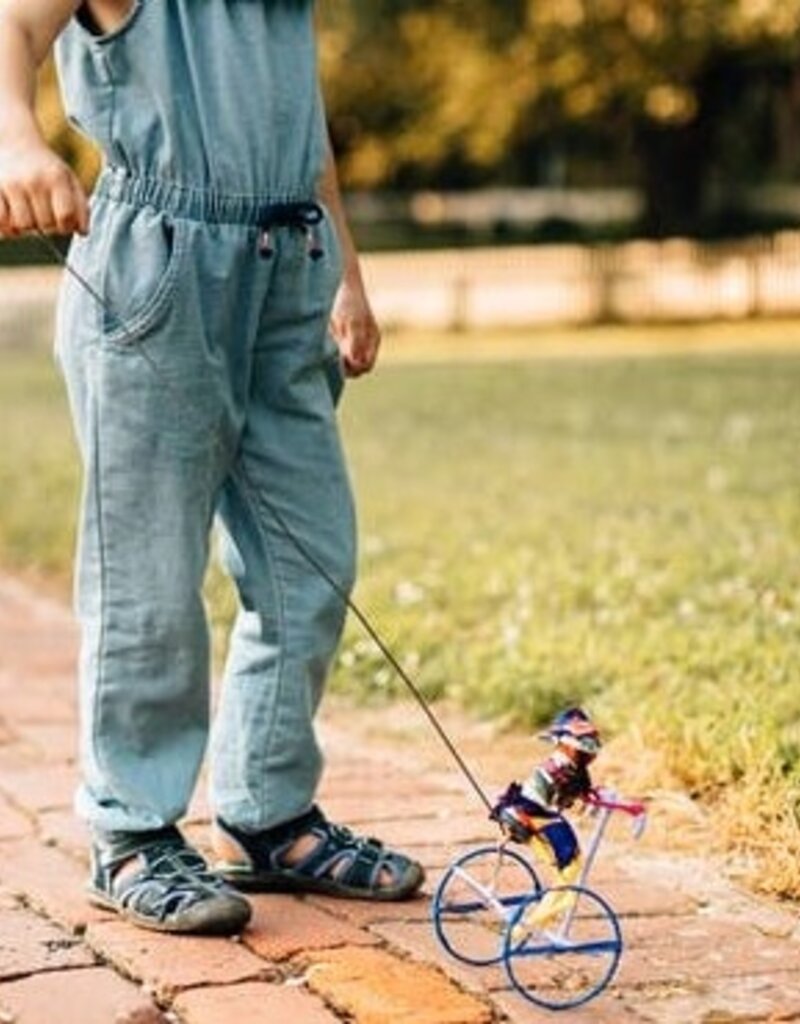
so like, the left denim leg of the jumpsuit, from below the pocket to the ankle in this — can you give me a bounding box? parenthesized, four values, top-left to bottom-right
(58, 205, 227, 834)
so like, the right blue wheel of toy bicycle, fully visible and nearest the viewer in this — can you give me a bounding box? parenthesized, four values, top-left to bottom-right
(503, 886, 623, 1010)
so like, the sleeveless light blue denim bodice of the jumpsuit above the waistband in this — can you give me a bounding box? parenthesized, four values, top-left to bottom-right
(56, 0, 327, 199)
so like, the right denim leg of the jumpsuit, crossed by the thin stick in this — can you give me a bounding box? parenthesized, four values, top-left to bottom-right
(212, 226, 355, 831)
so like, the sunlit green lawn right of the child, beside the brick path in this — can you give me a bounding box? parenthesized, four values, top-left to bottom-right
(344, 356, 800, 737)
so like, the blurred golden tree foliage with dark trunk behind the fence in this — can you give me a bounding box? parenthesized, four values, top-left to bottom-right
(325, 0, 800, 233)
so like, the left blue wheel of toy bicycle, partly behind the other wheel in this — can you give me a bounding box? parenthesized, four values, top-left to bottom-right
(431, 844, 542, 967)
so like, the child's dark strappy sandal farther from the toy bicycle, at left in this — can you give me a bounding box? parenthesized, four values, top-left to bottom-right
(88, 827, 251, 935)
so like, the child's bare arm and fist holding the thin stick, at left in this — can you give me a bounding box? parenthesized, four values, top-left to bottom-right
(0, 0, 89, 236)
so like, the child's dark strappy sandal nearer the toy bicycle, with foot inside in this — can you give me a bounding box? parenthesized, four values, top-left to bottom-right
(213, 807, 425, 900)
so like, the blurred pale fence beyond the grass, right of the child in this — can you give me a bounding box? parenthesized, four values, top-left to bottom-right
(365, 231, 800, 330)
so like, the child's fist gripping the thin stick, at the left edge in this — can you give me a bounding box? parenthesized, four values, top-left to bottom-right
(0, 142, 89, 238)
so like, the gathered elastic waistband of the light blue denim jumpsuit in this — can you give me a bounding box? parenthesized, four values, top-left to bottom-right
(94, 167, 315, 227)
